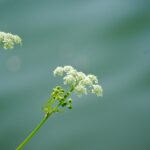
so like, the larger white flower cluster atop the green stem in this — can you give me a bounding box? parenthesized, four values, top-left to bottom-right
(53, 66, 103, 96)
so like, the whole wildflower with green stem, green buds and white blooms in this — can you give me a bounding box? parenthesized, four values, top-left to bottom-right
(16, 66, 103, 150)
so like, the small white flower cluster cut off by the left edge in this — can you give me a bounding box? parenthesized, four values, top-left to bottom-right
(0, 32, 22, 49)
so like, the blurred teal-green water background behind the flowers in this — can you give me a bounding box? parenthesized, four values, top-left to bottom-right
(0, 0, 150, 150)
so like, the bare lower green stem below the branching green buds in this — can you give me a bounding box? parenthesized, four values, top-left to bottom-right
(16, 112, 53, 150)
